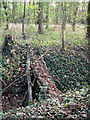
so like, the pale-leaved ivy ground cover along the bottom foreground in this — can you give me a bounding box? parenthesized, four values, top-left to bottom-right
(2, 88, 89, 120)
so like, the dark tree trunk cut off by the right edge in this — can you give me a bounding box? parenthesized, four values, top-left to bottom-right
(87, 1, 90, 71)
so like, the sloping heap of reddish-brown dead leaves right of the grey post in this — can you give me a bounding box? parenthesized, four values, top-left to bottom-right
(32, 54, 62, 101)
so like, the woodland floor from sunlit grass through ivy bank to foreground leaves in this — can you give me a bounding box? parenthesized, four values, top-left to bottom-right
(2, 24, 90, 120)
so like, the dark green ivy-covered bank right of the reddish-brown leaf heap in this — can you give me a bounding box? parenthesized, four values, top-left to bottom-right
(45, 46, 89, 91)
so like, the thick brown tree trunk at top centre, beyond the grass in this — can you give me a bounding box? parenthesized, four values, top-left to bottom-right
(38, 2, 44, 34)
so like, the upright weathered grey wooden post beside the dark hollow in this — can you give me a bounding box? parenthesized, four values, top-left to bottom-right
(26, 49, 32, 101)
